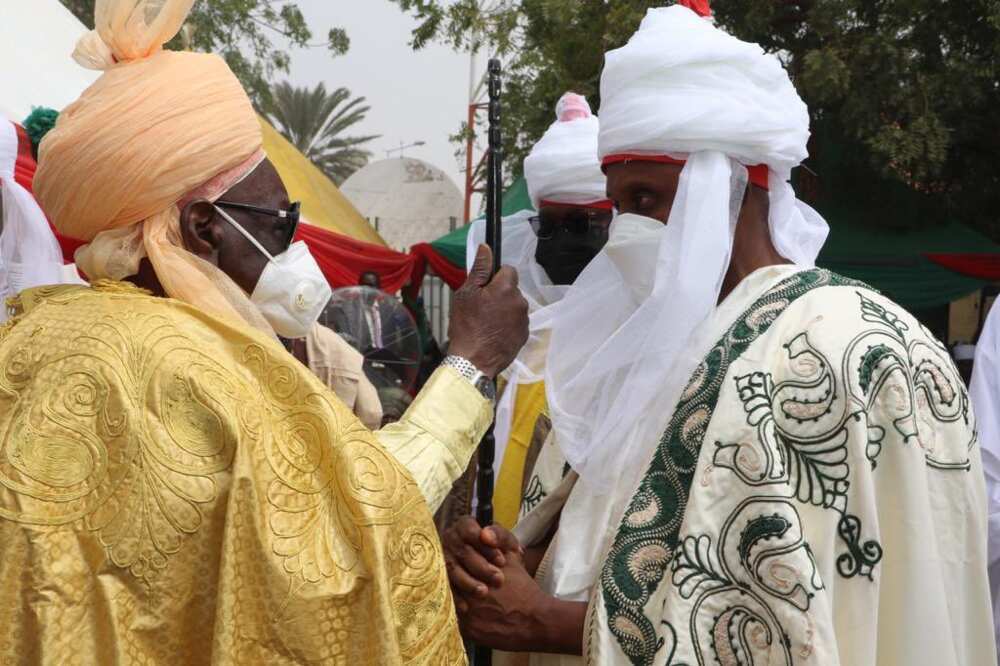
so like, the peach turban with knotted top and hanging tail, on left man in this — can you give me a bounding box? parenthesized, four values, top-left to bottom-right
(35, 0, 267, 330)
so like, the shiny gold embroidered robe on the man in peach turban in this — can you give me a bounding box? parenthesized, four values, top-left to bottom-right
(0, 283, 465, 666)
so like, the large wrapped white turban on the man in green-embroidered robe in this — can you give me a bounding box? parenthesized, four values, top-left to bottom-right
(599, 5, 809, 180)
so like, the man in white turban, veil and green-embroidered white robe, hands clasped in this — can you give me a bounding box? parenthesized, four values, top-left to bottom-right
(446, 0, 995, 666)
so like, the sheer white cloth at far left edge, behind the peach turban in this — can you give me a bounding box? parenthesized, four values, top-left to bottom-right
(0, 121, 63, 322)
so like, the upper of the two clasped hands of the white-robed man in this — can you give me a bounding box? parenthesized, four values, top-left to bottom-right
(441, 516, 523, 597)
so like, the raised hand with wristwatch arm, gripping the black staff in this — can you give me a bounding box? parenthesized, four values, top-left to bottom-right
(448, 245, 528, 377)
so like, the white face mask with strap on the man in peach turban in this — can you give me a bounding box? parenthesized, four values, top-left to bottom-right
(215, 206, 333, 338)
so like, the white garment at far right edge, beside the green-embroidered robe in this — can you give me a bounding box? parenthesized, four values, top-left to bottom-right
(969, 305, 1000, 647)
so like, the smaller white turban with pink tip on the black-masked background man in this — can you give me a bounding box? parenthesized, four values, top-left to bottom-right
(524, 93, 607, 210)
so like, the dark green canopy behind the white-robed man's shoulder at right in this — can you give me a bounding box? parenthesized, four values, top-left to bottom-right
(817, 218, 1000, 310)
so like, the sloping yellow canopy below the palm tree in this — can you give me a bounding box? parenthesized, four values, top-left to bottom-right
(260, 118, 387, 247)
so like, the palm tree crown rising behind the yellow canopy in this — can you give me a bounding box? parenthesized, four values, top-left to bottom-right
(264, 81, 379, 185)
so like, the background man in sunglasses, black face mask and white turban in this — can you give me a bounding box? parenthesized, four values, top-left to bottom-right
(454, 92, 612, 528)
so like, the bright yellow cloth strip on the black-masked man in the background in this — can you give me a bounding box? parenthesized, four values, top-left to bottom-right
(493, 382, 545, 529)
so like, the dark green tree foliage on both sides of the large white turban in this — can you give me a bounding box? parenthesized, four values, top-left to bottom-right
(393, 0, 1000, 237)
